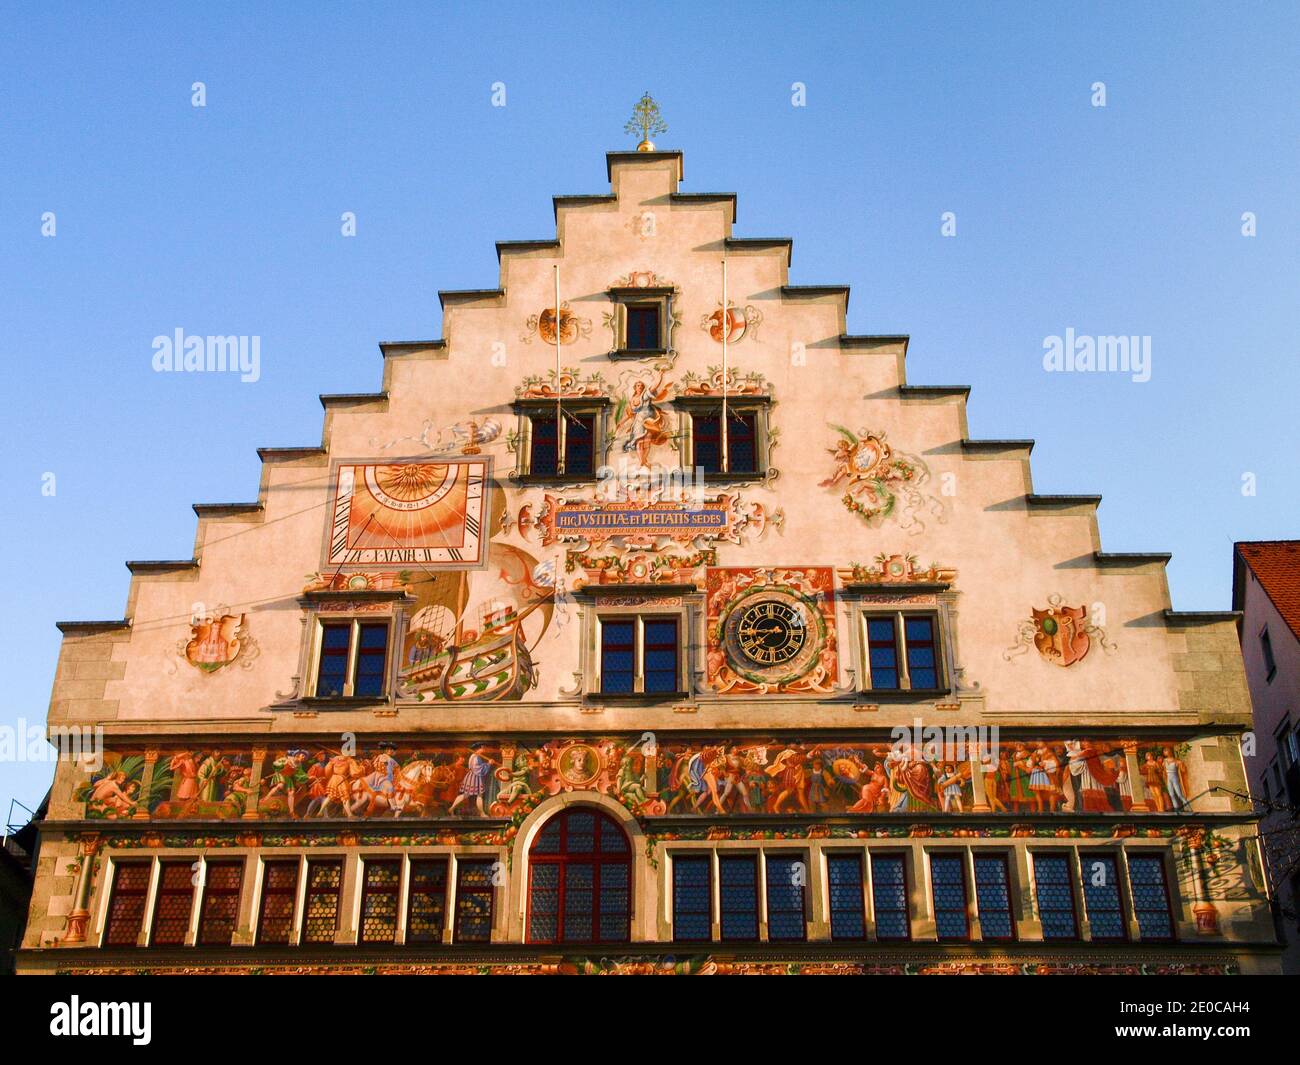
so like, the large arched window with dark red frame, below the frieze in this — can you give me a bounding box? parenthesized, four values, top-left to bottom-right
(528, 806, 632, 943)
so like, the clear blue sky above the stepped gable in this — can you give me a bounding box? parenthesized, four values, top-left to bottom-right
(0, 3, 1300, 809)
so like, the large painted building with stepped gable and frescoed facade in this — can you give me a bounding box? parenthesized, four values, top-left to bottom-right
(18, 137, 1282, 974)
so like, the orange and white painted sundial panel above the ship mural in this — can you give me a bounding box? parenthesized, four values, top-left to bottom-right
(325, 459, 490, 570)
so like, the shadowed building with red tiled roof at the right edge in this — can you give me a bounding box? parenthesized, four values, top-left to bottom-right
(1232, 540, 1300, 974)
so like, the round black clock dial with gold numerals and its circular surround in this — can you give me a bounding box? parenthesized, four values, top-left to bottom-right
(722, 586, 824, 684)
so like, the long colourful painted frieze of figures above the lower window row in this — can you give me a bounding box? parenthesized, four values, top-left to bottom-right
(74, 735, 1193, 837)
